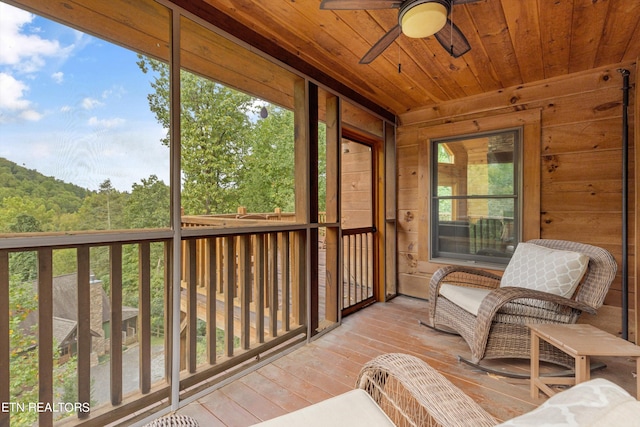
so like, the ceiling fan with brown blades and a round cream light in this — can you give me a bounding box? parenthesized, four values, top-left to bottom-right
(320, 0, 480, 64)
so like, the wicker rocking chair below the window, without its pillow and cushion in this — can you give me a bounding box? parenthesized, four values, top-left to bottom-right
(429, 239, 617, 368)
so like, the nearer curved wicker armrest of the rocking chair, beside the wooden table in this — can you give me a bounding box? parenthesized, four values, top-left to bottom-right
(472, 286, 596, 359)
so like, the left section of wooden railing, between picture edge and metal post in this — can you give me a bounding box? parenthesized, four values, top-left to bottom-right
(0, 237, 175, 426)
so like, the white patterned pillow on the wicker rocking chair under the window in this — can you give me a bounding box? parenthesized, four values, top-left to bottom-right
(500, 243, 589, 298)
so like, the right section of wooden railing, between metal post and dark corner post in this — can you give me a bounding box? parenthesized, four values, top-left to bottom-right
(181, 231, 306, 393)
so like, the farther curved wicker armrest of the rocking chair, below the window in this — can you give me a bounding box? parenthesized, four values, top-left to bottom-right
(428, 265, 501, 325)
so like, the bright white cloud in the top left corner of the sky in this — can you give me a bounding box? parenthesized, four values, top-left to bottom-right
(0, 3, 64, 73)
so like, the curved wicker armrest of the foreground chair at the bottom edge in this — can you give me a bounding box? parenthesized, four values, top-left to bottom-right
(356, 353, 498, 426)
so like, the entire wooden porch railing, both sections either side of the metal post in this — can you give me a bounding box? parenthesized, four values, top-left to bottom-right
(0, 222, 307, 426)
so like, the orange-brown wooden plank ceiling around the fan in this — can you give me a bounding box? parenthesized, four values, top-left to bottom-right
(190, 0, 640, 115)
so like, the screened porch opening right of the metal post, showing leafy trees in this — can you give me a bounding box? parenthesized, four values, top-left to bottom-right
(178, 17, 296, 228)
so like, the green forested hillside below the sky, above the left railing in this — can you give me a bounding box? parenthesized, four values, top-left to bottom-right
(0, 158, 169, 233)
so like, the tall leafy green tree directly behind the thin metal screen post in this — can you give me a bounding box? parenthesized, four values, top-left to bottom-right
(138, 56, 256, 215)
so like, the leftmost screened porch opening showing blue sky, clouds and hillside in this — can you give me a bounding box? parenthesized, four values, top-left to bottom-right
(0, 2, 170, 234)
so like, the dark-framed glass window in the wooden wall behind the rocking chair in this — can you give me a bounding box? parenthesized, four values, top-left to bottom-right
(430, 128, 522, 264)
